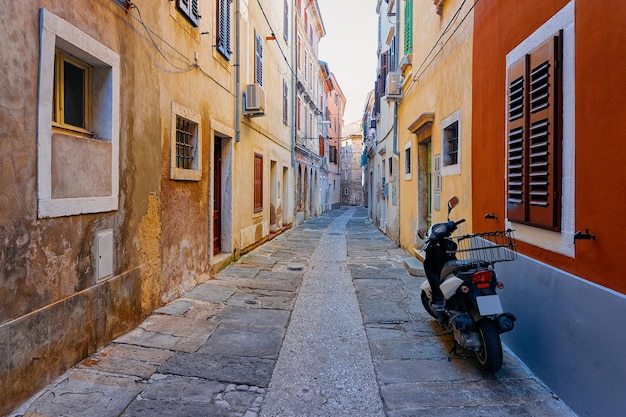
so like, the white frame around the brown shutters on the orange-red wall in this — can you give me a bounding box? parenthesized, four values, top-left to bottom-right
(503, 1, 576, 258)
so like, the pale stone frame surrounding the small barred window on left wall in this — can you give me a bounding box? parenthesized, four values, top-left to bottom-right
(170, 102, 202, 181)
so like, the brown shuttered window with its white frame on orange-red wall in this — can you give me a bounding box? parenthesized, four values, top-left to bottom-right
(503, 1, 576, 257)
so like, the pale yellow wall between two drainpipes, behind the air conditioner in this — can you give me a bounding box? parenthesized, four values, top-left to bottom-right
(232, 2, 293, 255)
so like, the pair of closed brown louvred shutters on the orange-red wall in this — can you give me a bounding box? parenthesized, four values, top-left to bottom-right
(507, 33, 562, 230)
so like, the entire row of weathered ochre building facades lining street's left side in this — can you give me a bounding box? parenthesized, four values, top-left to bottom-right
(0, 0, 338, 414)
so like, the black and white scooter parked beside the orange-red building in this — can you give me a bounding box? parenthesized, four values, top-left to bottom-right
(418, 197, 517, 372)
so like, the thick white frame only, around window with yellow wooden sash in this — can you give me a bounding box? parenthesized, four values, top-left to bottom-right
(37, 8, 120, 218)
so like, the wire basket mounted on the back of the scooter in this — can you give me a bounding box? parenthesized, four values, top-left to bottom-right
(453, 229, 517, 264)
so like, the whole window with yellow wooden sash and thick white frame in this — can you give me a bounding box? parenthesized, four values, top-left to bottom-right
(37, 9, 120, 218)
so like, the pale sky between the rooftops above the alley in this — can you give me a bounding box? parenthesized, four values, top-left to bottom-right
(317, 0, 378, 125)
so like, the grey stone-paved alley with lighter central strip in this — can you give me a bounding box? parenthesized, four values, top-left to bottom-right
(11, 207, 575, 417)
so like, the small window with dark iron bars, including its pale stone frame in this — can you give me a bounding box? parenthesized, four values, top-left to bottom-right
(170, 103, 202, 181)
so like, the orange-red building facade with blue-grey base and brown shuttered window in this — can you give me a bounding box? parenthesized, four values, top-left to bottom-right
(472, 0, 626, 416)
